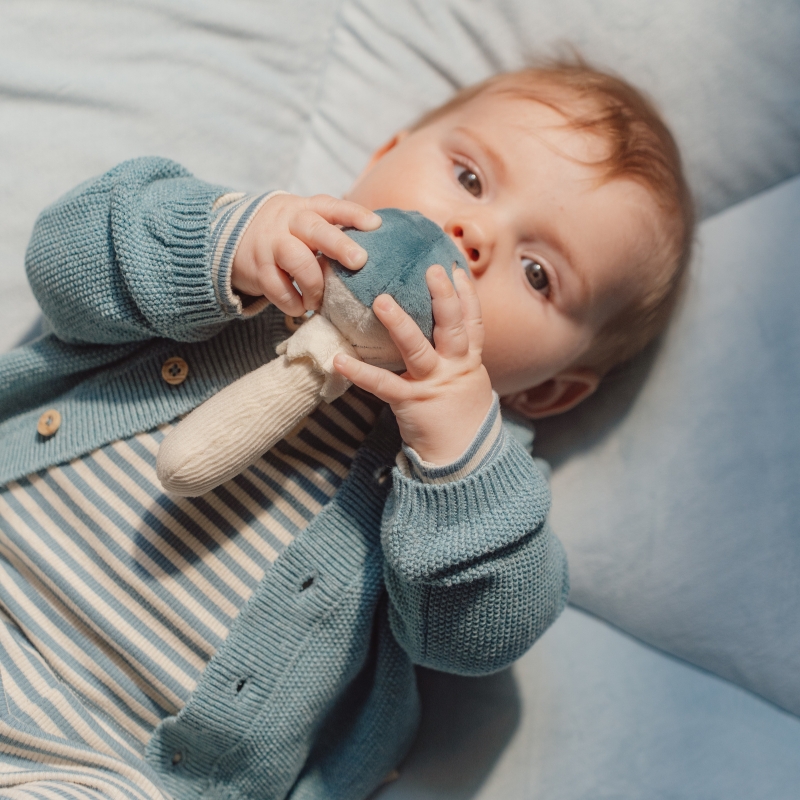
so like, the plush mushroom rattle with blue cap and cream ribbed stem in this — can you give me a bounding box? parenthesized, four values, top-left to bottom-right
(156, 208, 466, 497)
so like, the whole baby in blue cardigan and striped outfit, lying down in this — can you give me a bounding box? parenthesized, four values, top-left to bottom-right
(0, 65, 692, 800)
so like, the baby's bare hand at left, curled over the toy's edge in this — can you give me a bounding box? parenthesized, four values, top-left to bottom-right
(231, 194, 381, 317)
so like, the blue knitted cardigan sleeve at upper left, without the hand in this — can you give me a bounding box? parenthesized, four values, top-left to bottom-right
(26, 158, 276, 344)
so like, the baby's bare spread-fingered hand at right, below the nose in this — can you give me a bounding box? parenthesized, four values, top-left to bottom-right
(334, 265, 492, 465)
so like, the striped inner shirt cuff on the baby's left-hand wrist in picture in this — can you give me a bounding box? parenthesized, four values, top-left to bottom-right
(209, 189, 287, 317)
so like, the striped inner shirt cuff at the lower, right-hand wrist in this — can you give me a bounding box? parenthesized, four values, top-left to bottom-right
(397, 392, 505, 483)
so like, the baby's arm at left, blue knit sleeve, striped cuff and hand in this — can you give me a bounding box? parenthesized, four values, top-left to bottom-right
(26, 158, 380, 344)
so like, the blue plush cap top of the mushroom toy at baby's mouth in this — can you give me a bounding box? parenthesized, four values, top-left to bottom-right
(330, 208, 469, 341)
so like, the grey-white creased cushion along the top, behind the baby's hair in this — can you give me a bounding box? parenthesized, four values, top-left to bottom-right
(293, 0, 800, 216)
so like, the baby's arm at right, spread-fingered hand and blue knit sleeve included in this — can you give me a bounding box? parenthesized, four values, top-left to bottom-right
(337, 267, 569, 674)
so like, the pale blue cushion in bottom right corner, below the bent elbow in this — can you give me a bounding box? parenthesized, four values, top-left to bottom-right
(379, 608, 800, 800)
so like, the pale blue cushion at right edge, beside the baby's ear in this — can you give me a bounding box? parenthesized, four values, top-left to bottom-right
(534, 173, 800, 714)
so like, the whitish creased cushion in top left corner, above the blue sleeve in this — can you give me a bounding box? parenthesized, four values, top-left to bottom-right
(0, 0, 342, 349)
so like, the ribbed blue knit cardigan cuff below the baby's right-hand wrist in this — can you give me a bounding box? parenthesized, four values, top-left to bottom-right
(382, 436, 550, 582)
